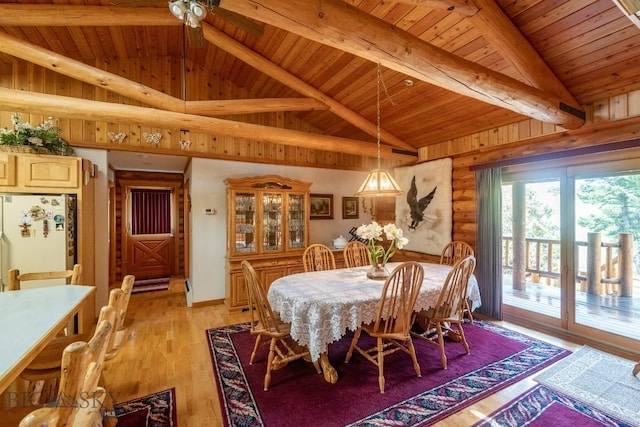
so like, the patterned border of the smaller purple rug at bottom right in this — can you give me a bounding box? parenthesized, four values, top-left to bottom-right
(472, 385, 634, 427)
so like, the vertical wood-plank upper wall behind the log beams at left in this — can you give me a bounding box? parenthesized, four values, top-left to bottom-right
(0, 57, 401, 170)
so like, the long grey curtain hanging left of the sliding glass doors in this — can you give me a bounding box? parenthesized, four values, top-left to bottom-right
(476, 168, 502, 320)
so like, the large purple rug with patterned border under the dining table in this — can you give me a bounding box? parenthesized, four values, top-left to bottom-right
(207, 321, 570, 427)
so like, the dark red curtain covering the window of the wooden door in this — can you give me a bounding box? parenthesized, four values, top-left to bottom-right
(131, 189, 171, 235)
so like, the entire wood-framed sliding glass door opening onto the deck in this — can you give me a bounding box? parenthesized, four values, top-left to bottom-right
(502, 152, 640, 351)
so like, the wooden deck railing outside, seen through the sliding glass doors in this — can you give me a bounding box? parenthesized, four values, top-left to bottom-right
(502, 233, 633, 297)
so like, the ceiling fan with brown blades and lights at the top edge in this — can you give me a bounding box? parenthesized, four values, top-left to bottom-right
(113, 0, 264, 47)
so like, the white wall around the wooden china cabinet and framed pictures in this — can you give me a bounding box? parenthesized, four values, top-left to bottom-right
(187, 158, 371, 302)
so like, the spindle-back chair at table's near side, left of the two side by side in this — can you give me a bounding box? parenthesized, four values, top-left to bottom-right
(345, 261, 424, 393)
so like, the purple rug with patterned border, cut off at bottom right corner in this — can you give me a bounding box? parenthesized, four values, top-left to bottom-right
(473, 385, 640, 427)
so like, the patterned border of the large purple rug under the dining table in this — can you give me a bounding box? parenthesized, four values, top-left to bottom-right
(206, 321, 571, 427)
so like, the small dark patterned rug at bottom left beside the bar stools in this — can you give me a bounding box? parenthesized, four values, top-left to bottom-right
(114, 388, 178, 427)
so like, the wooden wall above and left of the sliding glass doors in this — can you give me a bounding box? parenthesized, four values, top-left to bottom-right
(420, 91, 640, 252)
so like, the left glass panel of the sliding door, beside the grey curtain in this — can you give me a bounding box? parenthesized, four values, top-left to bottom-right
(502, 174, 563, 326)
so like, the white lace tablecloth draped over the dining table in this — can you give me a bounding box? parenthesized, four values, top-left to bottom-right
(268, 262, 480, 361)
